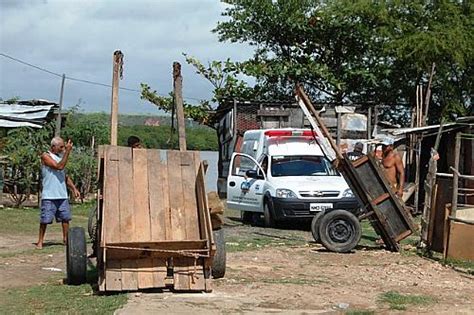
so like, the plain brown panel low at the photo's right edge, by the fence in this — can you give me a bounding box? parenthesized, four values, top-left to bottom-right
(447, 221, 474, 261)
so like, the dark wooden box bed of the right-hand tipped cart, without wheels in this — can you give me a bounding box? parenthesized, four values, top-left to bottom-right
(339, 155, 416, 251)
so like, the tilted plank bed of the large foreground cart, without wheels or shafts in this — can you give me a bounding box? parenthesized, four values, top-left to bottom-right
(98, 146, 215, 291)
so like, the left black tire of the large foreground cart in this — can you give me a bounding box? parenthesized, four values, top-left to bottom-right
(66, 226, 87, 285)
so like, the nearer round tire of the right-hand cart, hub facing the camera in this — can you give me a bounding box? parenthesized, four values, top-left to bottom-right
(319, 210, 362, 253)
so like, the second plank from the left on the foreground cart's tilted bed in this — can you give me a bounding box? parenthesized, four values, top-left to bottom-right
(116, 147, 135, 242)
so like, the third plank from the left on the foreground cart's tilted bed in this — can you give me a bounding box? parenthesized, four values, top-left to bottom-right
(133, 149, 151, 242)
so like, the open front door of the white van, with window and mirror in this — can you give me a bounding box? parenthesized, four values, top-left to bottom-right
(227, 153, 266, 212)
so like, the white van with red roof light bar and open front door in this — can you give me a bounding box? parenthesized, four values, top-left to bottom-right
(227, 128, 359, 227)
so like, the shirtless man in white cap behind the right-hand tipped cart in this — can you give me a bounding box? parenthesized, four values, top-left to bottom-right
(382, 138, 405, 198)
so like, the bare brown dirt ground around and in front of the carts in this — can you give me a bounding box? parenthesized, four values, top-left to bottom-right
(0, 218, 474, 314)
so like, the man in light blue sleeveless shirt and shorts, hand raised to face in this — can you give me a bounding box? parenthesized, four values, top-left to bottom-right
(36, 137, 80, 249)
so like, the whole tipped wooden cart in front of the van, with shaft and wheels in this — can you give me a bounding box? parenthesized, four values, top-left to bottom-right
(296, 85, 416, 252)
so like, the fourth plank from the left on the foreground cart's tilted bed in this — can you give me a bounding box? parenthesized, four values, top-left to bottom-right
(147, 150, 168, 241)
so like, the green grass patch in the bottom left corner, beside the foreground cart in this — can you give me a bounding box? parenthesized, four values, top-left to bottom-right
(0, 281, 127, 314)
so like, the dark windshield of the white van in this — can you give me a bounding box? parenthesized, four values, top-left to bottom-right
(271, 155, 339, 177)
